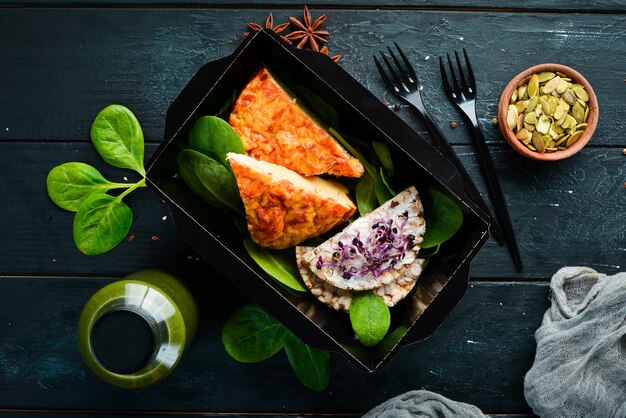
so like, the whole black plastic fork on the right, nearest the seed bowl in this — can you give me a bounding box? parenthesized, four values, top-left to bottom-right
(439, 48, 524, 272)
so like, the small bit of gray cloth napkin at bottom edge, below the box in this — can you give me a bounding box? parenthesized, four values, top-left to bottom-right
(363, 390, 488, 418)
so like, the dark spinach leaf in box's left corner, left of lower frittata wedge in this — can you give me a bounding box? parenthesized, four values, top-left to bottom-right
(178, 149, 243, 215)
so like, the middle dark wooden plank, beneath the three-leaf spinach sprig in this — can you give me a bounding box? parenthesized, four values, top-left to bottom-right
(0, 142, 626, 279)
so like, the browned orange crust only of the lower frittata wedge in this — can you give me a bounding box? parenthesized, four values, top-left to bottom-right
(230, 160, 355, 249)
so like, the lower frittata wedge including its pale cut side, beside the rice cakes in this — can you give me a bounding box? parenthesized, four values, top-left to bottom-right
(228, 153, 356, 249)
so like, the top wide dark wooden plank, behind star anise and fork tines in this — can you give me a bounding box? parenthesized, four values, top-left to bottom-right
(0, 9, 626, 146)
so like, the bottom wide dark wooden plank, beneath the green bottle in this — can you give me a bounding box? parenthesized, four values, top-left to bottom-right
(0, 278, 548, 414)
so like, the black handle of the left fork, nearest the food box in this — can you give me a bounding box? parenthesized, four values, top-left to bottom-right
(416, 110, 505, 245)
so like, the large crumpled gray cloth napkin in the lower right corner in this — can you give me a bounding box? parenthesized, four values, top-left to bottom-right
(524, 267, 626, 418)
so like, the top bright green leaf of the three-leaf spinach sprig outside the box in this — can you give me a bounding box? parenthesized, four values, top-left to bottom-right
(91, 105, 146, 176)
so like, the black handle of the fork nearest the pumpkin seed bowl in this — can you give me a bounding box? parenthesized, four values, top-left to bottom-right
(472, 123, 524, 272)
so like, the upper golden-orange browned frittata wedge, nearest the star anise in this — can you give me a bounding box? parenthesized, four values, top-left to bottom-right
(229, 67, 363, 177)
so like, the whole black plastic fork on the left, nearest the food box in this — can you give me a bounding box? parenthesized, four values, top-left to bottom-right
(374, 42, 504, 244)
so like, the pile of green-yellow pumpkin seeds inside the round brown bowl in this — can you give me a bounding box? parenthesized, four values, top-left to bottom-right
(506, 71, 589, 154)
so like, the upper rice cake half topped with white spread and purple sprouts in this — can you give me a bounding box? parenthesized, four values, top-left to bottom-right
(303, 186, 426, 291)
